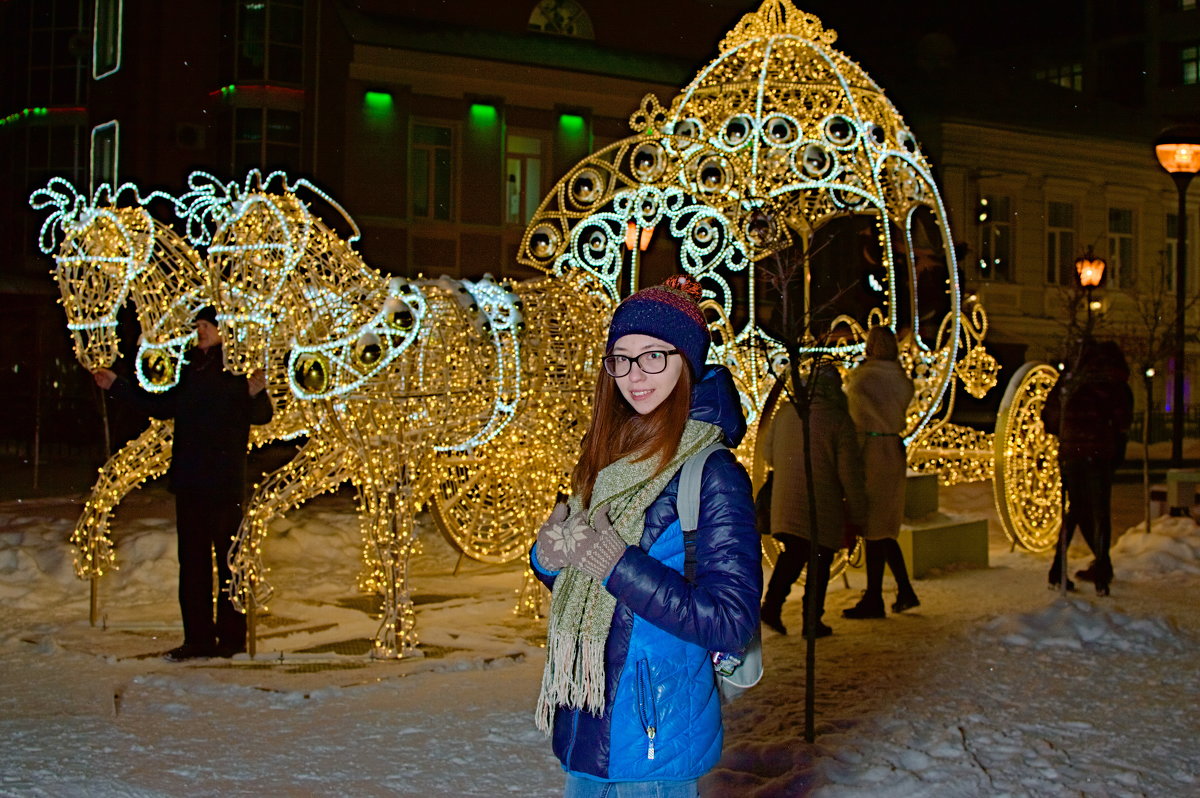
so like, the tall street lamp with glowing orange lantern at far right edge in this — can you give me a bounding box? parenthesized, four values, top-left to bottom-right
(1154, 125, 1200, 468)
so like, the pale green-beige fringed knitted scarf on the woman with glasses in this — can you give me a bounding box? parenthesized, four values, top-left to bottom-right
(534, 419, 721, 734)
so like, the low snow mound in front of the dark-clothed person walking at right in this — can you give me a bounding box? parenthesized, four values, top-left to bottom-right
(982, 598, 1184, 654)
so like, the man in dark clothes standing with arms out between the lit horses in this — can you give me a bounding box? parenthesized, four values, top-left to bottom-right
(94, 306, 272, 662)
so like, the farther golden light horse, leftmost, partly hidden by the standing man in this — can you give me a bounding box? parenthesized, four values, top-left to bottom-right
(30, 178, 302, 623)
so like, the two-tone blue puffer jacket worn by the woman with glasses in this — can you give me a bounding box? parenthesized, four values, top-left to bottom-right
(530, 366, 762, 781)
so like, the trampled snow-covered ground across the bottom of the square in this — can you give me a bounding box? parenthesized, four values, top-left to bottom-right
(0, 475, 1200, 797)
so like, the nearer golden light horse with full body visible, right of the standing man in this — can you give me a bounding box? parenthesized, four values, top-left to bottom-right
(181, 173, 608, 658)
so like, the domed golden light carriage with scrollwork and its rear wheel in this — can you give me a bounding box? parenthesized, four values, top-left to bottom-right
(518, 0, 1058, 553)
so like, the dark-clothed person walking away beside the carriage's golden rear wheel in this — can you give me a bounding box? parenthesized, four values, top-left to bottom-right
(1042, 338, 1133, 595)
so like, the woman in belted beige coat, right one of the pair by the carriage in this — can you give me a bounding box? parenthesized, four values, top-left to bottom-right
(841, 326, 920, 618)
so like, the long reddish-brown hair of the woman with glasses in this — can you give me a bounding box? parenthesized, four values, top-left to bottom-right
(571, 365, 691, 506)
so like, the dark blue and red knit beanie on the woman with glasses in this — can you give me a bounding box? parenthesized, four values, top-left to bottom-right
(605, 275, 712, 377)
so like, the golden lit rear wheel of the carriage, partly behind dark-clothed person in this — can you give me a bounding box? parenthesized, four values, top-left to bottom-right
(992, 362, 1062, 552)
